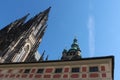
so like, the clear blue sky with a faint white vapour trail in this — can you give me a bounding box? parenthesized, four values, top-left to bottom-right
(0, 0, 120, 80)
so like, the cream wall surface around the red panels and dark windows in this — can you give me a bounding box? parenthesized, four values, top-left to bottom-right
(0, 59, 112, 80)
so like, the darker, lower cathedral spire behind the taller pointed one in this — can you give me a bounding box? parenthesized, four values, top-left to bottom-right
(0, 14, 29, 52)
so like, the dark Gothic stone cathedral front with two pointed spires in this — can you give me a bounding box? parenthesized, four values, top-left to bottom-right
(0, 7, 50, 63)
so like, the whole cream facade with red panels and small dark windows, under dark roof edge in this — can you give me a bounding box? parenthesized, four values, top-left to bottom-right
(0, 56, 114, 80)
